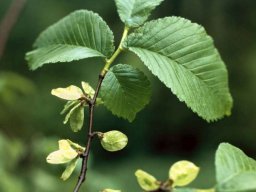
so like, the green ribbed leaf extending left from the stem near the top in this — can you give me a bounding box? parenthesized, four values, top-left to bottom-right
(26, 10, 114, 70)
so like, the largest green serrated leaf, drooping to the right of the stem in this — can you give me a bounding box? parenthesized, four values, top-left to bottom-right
(124, 17, 232, 121)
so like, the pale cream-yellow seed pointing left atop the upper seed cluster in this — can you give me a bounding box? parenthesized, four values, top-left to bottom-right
(51, 85, 83, 100)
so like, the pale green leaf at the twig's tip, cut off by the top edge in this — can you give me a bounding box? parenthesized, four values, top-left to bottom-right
(115, 0, 163, 27)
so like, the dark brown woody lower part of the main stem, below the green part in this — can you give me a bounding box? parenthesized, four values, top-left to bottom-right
(74, 74, 105, 192)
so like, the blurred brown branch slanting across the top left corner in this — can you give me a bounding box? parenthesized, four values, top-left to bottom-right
(0, 0, 27, 59)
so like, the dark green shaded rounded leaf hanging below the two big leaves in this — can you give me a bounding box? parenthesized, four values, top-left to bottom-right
(101, 64, 151, 122)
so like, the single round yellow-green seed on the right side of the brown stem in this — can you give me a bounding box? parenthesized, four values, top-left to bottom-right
(100, 130, 128, 152)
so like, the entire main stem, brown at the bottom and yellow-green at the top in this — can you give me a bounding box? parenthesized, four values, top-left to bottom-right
(74, 27, 129, 192)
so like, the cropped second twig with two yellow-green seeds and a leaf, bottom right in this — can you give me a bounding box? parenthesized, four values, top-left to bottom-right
(135, 143, 256, 192)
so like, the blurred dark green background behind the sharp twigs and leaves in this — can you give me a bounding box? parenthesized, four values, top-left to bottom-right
(0, 0, 256, 192)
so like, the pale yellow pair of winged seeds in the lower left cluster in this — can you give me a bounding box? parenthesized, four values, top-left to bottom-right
(46, 140, 78, 164)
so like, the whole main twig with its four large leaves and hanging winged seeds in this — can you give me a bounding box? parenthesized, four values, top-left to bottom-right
(26, 0, 237, 192)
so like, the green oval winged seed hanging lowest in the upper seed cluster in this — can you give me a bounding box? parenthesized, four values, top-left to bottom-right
(69, 106, 84, 132)
